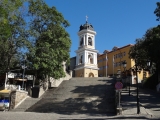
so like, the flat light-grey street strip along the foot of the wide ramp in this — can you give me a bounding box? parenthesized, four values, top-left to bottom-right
(0, 112, 154, 120)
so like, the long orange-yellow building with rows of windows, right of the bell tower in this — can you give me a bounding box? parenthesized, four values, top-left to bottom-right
(97, 44, 148, 84)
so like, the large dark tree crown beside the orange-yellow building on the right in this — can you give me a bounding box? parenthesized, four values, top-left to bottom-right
(129, 25, 160, 69)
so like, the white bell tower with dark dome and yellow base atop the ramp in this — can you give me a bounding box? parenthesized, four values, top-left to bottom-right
(74, 21, 98, 77)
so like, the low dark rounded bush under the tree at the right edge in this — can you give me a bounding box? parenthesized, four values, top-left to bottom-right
(143, 74, 158, 89)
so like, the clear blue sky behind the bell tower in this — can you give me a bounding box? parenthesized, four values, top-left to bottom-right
(45, 0, 160, 57)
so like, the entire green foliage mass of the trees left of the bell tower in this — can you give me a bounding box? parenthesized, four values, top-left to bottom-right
(0, 0, 71, 78)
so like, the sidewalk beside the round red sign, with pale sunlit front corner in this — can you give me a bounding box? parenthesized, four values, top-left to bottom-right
(121, 87, 153, 118)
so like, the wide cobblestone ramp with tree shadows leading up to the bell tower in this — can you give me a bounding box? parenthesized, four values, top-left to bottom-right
(26, 78, 115, 115)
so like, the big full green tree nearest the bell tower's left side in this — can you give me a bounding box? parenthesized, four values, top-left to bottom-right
(29, 0, 71, 79)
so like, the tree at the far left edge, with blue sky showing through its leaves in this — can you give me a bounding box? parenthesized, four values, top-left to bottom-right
(0, 0, 27, 73)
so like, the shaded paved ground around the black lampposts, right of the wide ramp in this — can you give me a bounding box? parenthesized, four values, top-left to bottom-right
(121, 87, 160, 120)
